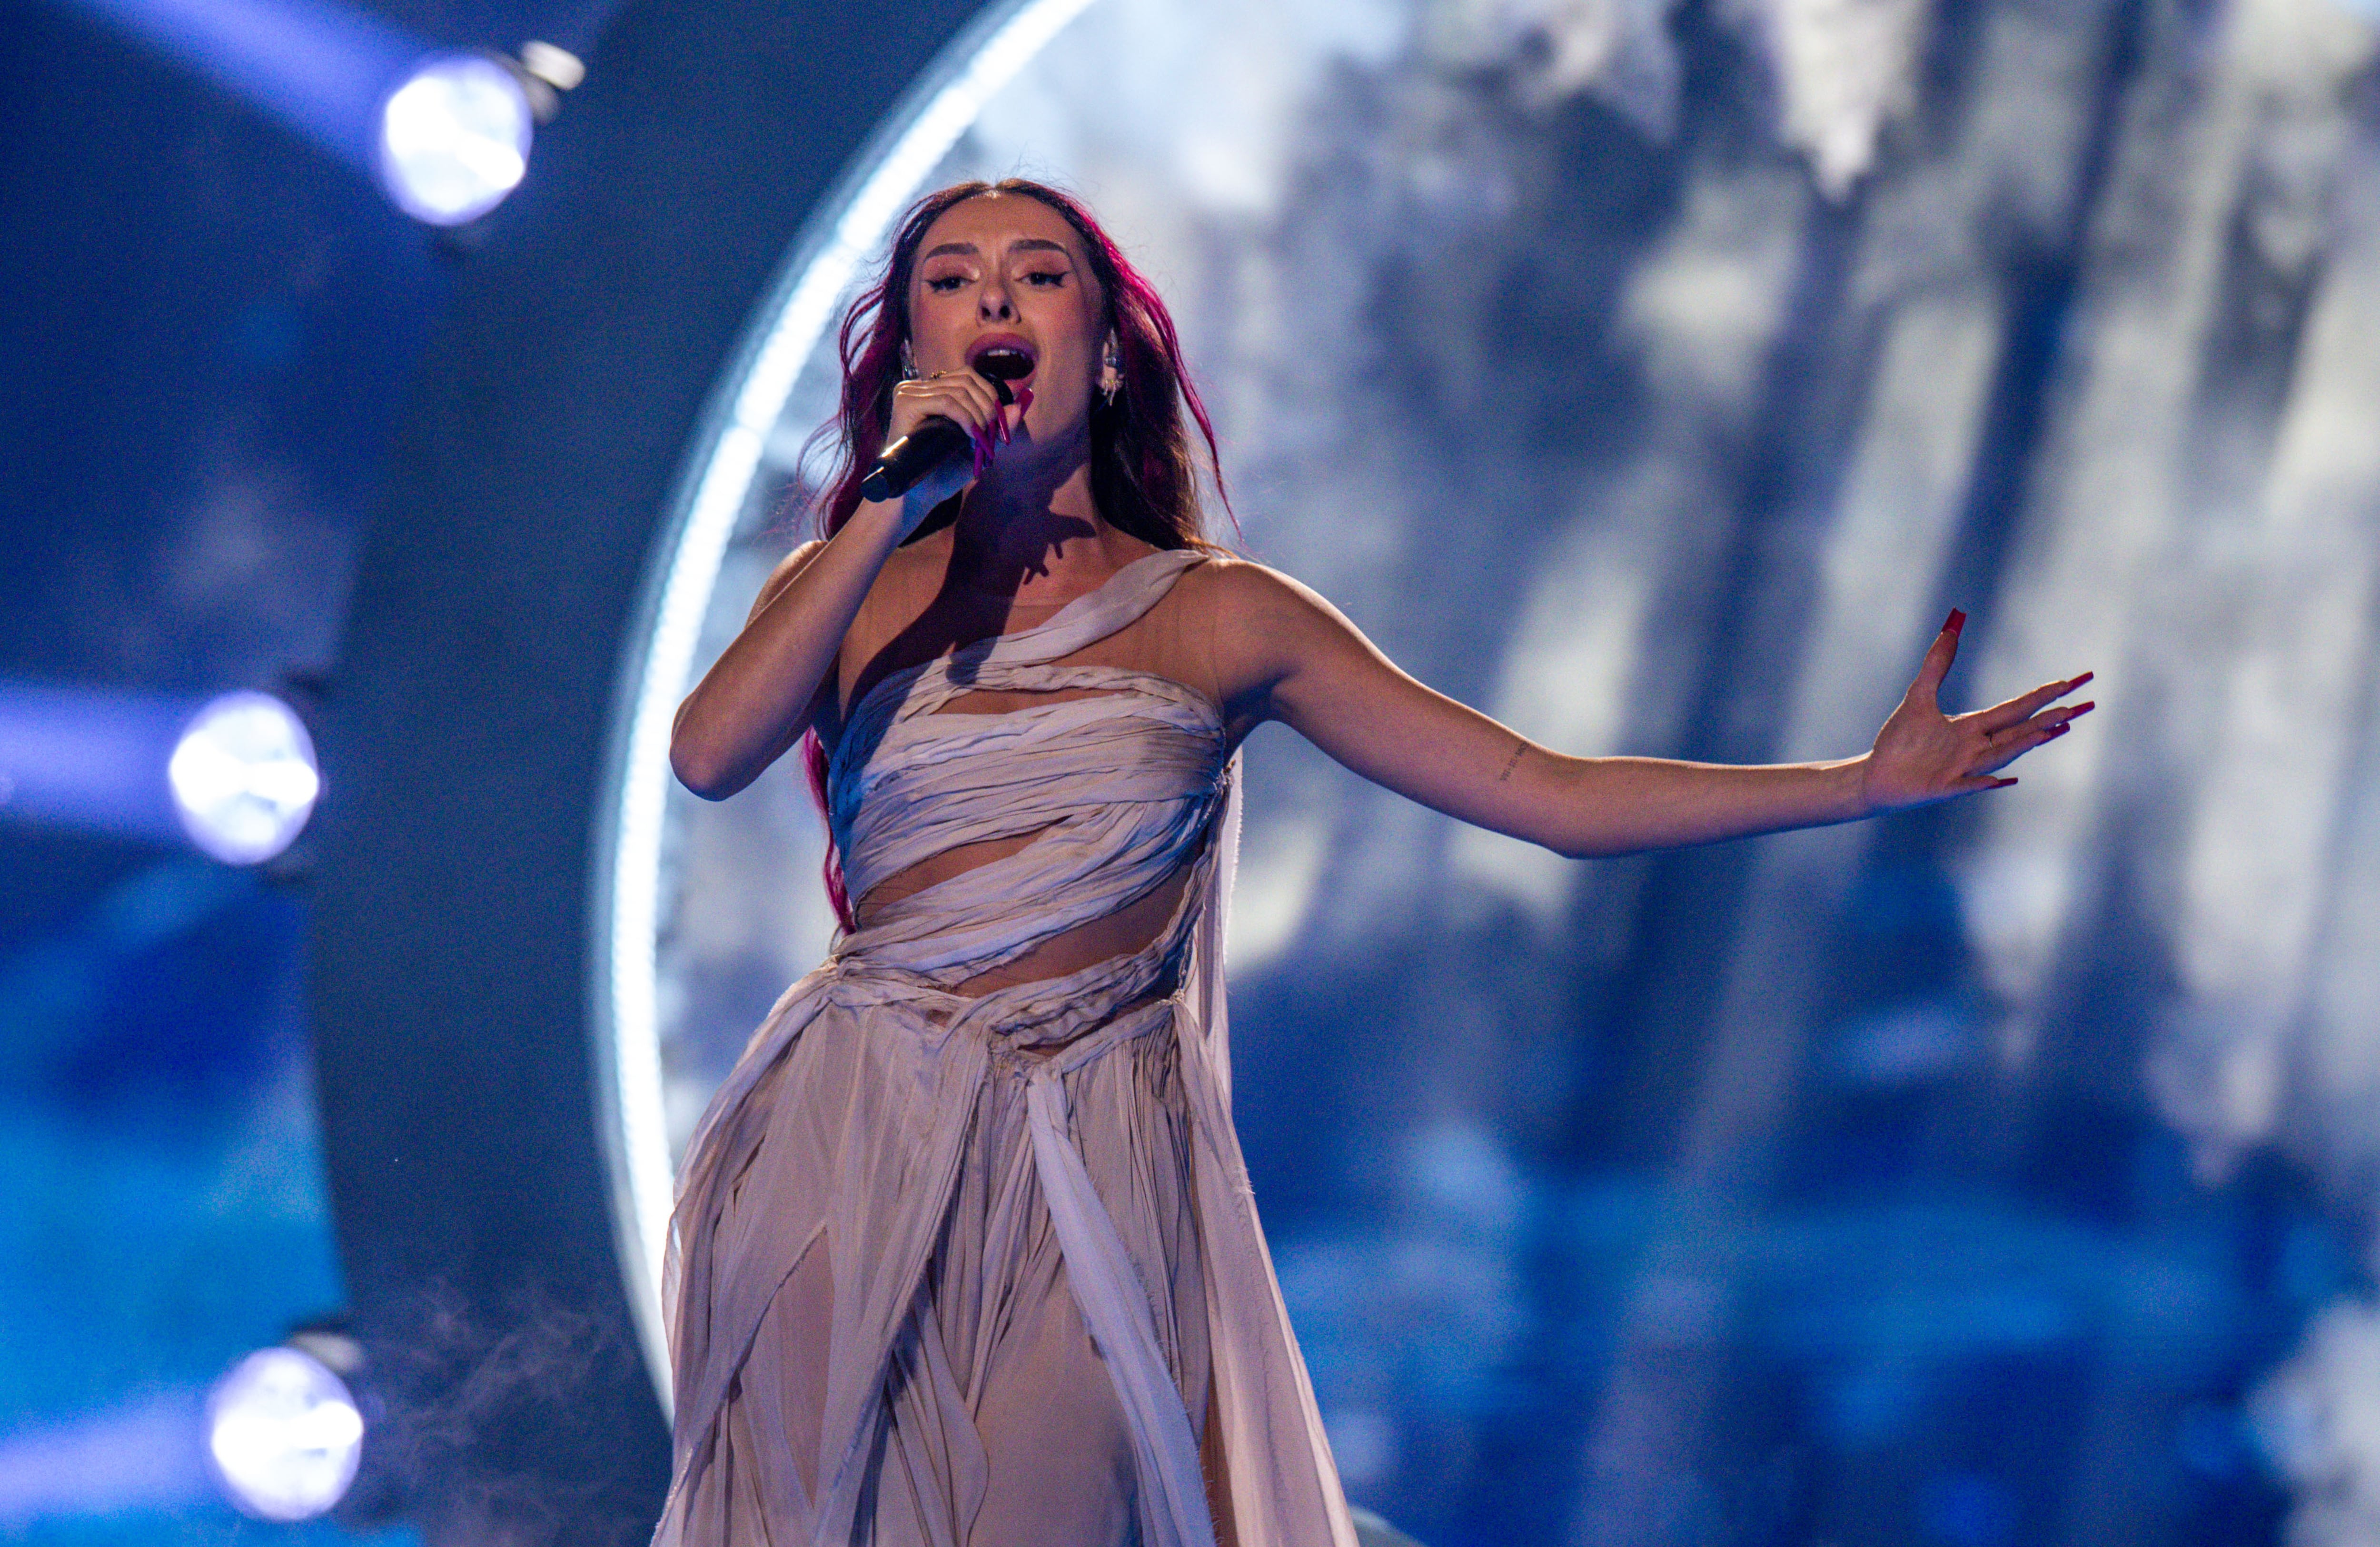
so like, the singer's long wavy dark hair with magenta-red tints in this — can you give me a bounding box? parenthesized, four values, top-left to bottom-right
(802, 176, 1238, 931)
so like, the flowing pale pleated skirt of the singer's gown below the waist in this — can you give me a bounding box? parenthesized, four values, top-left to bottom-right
(654, 776, 1357, 1547)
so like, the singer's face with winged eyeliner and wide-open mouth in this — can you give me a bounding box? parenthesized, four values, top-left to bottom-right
(909, 193, 1107, 443)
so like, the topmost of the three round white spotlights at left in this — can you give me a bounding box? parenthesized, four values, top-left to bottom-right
(381, 55, 536, 226)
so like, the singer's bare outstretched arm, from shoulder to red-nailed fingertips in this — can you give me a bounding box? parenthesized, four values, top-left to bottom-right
(1216, 564, 2092, 857)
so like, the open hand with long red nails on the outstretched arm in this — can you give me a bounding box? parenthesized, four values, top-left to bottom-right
(1861, 612, 2092, 816)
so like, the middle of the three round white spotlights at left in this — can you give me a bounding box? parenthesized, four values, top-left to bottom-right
(169, 693, 321, 864)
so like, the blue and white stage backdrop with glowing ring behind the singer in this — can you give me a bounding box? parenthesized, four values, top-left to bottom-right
(0, 0, 2380, 1547)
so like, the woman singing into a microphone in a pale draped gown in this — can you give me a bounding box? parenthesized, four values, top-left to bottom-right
(657, 178, 2090, 1547)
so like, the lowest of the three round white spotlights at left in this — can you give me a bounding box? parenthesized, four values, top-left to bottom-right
(207, 1347, 364, 1521)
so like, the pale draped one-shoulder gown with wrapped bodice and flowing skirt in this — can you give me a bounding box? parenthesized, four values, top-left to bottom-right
(654, 550, 1354, 1547)
